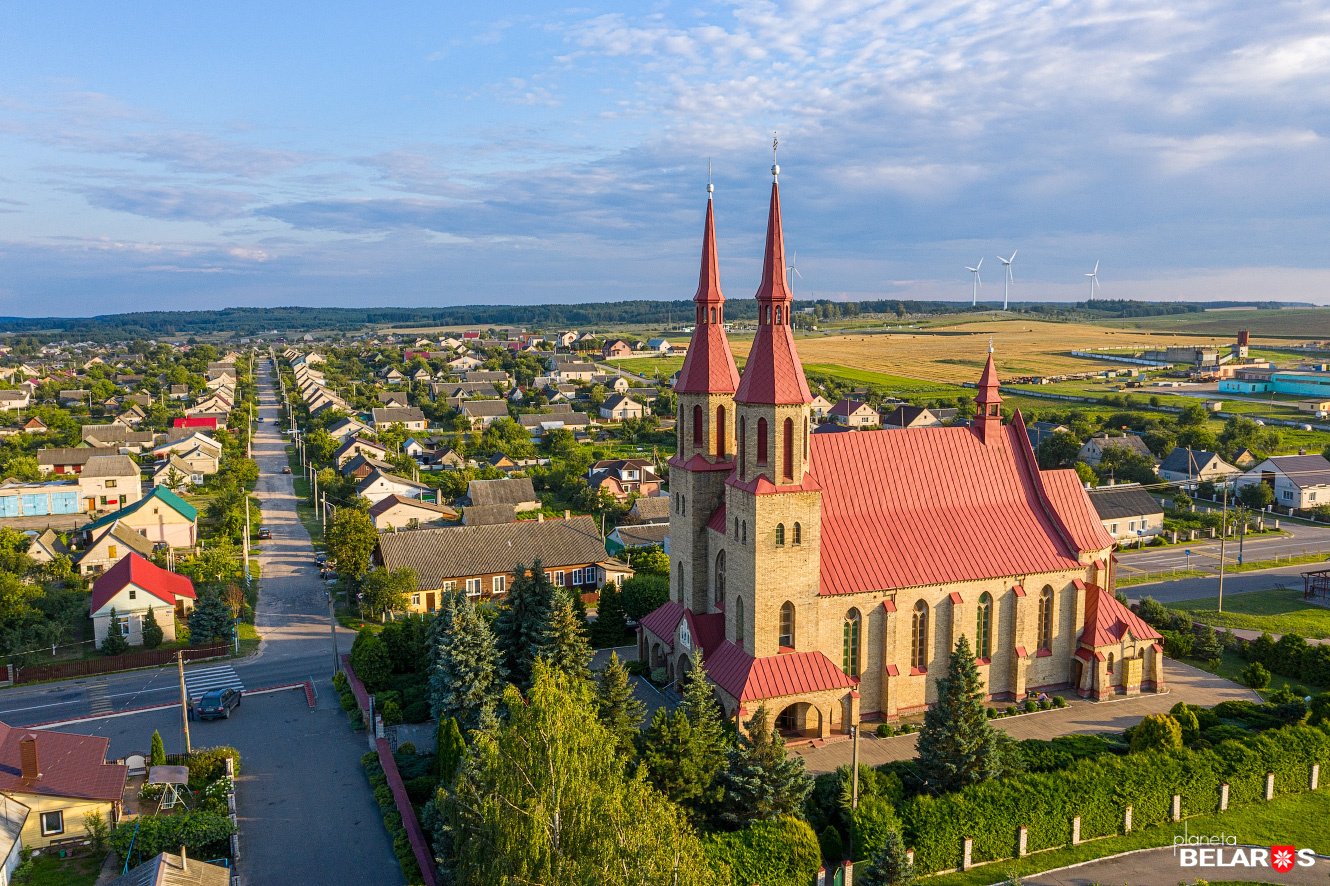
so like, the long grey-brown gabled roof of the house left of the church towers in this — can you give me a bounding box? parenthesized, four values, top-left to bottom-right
(376, 516, 622, 591)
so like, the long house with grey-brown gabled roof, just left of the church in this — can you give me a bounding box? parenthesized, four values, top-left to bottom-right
(374, 516, 633, 612)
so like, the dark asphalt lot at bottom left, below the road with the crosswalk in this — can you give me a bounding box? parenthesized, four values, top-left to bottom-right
(48, 682, 402, 886)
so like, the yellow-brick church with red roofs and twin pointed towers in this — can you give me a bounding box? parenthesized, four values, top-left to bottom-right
(638, 165, 1165, 738)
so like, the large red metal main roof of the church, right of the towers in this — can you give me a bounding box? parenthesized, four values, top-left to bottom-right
(810, 422, 1112, 595)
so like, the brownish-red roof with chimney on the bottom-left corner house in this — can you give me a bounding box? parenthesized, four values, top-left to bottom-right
(0, 722, 128, 801)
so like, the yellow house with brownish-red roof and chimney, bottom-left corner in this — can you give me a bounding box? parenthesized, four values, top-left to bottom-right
(0, 722, 128, 850)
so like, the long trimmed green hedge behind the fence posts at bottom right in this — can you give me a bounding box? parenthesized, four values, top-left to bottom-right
(902, 726, 1330, 873)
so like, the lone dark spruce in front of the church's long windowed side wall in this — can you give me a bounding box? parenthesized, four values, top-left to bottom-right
(919, 636, 1003, 793)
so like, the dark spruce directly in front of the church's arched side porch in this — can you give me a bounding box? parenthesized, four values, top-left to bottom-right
(720, 706, 813, 827)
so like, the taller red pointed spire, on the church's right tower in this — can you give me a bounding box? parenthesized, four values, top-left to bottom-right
(734, 165, 813, 404)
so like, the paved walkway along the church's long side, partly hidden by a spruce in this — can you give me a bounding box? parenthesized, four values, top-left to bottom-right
(794, 659, 1261, 774)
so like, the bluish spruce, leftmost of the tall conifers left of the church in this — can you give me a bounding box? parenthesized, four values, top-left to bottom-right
(430, 590, 503, 730)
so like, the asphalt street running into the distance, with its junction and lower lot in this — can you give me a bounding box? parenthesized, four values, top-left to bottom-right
(0, 363, 402, 886)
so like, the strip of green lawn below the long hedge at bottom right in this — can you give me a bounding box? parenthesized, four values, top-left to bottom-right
(923, 789, 1330, 886)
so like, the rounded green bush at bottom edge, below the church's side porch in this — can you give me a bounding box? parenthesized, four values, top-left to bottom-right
(702, 815, 822, 886)
